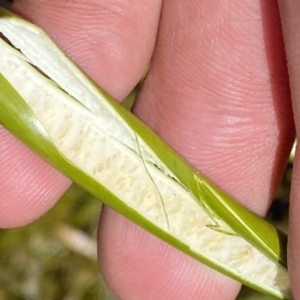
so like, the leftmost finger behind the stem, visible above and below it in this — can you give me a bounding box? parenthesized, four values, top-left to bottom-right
(0, 0, 160, 227)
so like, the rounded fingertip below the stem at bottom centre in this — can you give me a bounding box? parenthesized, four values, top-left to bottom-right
(98, 208, 240, 300)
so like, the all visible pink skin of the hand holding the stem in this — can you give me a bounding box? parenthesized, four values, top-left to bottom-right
(0, 0, 300, 300)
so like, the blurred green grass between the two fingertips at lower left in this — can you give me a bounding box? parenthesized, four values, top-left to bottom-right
(0, 186, 116, 300)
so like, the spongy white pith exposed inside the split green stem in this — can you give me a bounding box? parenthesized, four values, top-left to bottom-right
(0, 12, 289, 296)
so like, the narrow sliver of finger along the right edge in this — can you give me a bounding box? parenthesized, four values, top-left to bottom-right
(279, 1, 300, 299)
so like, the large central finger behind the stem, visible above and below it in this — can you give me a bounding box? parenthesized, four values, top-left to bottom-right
(99, 0, 294, 300)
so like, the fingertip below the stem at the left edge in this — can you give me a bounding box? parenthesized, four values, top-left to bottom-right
(0, 127, 70, 228)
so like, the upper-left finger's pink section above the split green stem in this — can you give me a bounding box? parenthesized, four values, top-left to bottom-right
(12, 0, 161, 100)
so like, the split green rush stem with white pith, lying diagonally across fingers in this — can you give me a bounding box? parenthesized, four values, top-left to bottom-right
(0, 9, 291, 299)
